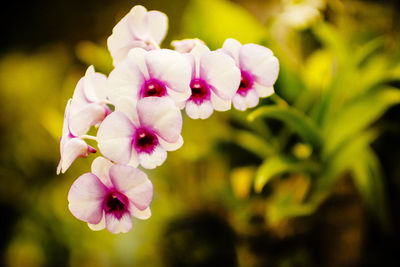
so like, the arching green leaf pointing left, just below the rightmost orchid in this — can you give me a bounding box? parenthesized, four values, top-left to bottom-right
(248, 106, 322, 146)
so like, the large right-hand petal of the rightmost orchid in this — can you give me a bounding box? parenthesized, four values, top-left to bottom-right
(239, 44, 279, 87)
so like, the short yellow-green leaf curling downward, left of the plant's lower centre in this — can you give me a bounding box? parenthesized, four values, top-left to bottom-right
(254, 156, 319, 192)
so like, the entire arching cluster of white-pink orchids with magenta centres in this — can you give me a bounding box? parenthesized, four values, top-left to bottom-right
(57, 6, 279, 233)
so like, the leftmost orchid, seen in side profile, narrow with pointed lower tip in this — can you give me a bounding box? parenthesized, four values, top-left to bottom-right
(57, 99, 96, 174)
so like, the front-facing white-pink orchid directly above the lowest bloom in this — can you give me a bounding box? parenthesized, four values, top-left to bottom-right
(97, 97, 183, 169)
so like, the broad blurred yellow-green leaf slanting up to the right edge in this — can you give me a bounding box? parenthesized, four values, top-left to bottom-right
(323, 89, 400, 157)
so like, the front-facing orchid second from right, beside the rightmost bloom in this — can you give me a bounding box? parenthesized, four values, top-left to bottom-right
(185, 44, 240, 119)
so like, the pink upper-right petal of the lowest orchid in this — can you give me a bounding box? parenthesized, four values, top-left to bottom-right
(110, 165, 153, 210)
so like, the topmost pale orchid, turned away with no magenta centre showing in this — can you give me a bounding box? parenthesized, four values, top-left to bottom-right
(107, 6, 168, 66)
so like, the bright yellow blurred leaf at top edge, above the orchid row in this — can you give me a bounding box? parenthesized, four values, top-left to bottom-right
(182, 0, 266, 48)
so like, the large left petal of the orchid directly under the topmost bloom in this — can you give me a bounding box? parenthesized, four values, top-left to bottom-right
(107, 55, 144, 102)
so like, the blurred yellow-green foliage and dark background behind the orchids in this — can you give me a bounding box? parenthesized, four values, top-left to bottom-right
(0, 0, 400, 267)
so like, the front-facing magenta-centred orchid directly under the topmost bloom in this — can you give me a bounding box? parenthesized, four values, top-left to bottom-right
(108, 48, 190, 109)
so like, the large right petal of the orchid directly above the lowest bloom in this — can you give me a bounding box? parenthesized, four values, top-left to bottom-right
(137, 97, 182, 142)
